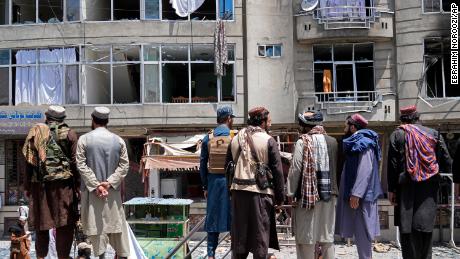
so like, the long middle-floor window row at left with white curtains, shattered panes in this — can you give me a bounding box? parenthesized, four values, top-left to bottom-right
(0, 44, 236, 105)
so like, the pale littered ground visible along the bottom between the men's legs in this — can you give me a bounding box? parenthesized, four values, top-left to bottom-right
(0, 241, 460, 259)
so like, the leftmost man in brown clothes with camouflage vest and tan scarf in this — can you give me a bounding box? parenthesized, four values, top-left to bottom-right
(23, 106, 80, 259)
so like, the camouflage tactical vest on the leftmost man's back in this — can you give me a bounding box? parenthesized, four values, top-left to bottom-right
(39, 123, 72, 182)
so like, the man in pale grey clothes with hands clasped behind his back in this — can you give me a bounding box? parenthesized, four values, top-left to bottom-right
(77, 107, 129, 258)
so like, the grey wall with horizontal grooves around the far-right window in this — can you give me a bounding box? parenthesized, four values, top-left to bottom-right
(395, 0, 460, 123)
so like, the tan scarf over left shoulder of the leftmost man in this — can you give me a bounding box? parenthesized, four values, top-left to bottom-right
(22, 123, 50, 166)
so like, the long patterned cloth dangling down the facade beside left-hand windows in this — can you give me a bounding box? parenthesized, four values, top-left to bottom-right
(214, 19, 228, 76)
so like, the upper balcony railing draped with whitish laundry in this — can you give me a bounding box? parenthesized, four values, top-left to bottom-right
(298, 5, 390, 30)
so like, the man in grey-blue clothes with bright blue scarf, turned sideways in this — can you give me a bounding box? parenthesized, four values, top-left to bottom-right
(335, 114, 383, 259)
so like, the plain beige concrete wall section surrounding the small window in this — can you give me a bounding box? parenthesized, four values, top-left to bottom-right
(246, 0, 296, 124)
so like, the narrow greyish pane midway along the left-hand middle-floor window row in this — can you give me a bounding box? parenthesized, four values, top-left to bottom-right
(144, 64, 160, 103)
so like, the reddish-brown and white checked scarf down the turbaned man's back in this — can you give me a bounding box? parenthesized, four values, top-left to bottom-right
(301, 126, 326, 209)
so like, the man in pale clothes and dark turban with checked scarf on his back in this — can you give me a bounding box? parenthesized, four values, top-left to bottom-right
(287, 112, 338, 259)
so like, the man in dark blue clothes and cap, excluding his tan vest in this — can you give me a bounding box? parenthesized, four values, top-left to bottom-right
(200, 107, 235, 259)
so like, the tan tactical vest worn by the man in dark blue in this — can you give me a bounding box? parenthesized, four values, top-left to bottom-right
(208, 130, 237, 174)
